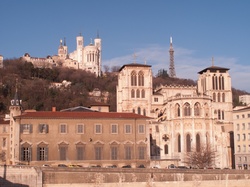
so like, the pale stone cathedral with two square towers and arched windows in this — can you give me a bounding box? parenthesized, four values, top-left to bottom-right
(117, 63, 234, 168)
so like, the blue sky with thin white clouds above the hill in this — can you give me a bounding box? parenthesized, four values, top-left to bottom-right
(0, 0, 250, 92)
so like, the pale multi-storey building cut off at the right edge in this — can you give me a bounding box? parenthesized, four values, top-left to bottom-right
(233, 106, 250, 169)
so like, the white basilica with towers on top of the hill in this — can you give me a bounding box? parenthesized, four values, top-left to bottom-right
(22, 34, 101, 76)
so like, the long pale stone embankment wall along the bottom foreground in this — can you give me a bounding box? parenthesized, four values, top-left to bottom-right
(0, 166, 250, 187)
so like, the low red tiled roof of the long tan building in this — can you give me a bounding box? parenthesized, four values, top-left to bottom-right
(16, 111, 150, 119)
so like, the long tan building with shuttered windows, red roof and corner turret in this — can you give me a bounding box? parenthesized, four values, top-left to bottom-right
(8, 93, 149, 167)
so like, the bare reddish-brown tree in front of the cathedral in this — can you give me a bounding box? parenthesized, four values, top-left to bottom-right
(184, 144, 216, 168)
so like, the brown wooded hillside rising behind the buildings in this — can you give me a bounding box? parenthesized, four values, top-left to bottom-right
(0, 59, 247, 114)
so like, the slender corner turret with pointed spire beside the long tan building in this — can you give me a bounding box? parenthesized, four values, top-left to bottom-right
(9, 79, 22, 165)
